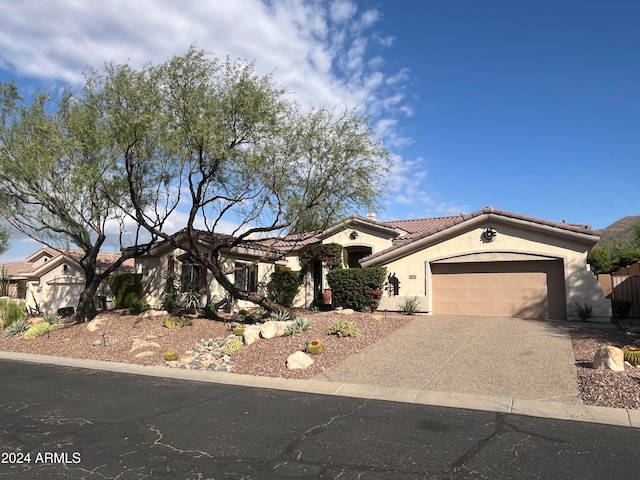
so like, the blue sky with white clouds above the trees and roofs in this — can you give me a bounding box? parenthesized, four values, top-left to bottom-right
(0, 0, 640, 262)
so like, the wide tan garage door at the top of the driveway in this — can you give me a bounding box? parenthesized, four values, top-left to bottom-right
(431, 260, 566, 319)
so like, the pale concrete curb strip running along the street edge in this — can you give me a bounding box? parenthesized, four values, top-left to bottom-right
(0, 352, 640, 428)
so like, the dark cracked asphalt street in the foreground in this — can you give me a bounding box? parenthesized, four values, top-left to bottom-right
(0, 361, 640, 480)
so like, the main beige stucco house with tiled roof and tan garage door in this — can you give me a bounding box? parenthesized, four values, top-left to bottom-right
(136, 207, 611, 321)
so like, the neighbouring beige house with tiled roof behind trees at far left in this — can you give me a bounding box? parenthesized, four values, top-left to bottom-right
(0, 247, 133, 313)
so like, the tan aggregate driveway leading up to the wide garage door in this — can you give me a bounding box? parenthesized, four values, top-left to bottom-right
(314, 315, 581, 403)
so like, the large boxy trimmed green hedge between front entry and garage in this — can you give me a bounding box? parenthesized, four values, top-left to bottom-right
(327, 267, 387, 312)
